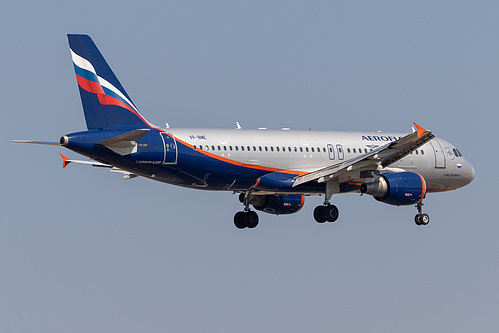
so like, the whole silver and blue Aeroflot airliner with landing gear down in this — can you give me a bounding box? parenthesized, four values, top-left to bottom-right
(14, 35, 475, 229)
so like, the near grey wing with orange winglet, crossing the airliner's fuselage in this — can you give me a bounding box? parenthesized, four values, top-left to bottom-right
(293, 123, 435, 187)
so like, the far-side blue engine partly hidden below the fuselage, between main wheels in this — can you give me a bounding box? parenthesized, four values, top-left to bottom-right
(249, 195, 305, 215)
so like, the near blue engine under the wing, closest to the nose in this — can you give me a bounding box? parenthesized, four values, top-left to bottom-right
(360, 172, 426, 206)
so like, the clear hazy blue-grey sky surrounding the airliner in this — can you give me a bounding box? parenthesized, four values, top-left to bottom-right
(0, 0, 499, 332)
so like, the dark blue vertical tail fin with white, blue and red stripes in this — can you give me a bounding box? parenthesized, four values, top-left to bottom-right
(68, 35, 151, 130)
